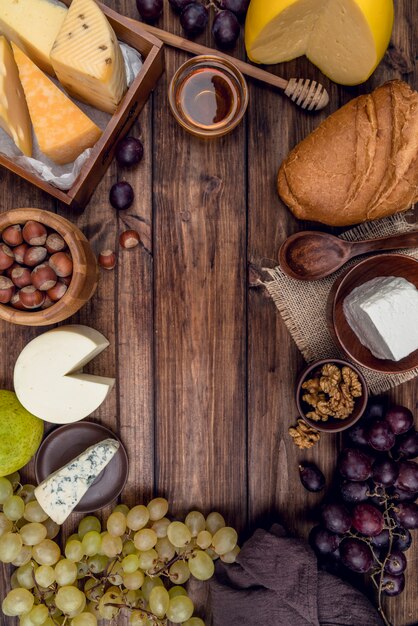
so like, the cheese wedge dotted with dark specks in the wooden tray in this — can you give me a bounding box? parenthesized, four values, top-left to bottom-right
(51, 0, 127, 113)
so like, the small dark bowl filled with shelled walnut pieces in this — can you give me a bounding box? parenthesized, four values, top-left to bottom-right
(296, 359, 368, 432)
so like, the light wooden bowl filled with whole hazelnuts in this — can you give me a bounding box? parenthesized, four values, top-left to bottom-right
(0, 208, 98, 326)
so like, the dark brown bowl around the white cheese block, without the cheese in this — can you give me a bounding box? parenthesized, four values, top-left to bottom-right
(328, 254, 418, 374)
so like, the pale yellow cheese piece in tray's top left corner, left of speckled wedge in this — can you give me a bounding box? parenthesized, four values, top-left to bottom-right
(0, 0, 68, 75)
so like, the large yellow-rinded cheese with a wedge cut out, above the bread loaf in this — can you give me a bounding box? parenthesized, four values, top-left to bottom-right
(245, 0, 394, 85)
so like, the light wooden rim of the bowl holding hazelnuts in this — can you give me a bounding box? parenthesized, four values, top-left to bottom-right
(0, 207, 94, 325)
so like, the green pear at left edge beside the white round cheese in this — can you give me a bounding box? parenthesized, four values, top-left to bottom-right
(0, 390, 44, 476)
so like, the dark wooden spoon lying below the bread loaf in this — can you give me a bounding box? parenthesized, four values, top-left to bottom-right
(279, 230, 418, 280)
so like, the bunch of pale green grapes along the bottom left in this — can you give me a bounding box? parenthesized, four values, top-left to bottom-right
(0, 472, 239, 626)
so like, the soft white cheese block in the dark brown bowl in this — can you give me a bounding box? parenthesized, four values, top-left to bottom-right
(343, 276, 418, 361)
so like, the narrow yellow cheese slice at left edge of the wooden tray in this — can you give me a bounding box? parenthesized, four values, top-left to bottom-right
(0, 36, 32, 156)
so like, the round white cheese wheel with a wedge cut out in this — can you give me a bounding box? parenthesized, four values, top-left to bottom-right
(14, 324, 115, 424)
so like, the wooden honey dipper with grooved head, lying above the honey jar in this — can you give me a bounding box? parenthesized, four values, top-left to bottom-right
(136, 22, 329, 111)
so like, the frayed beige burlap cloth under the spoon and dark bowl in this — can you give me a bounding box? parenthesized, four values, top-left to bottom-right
(264, 215, 418, 394)
